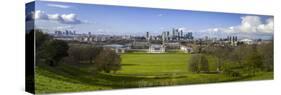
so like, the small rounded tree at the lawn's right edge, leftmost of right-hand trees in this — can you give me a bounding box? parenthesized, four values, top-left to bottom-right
(188, 54, 209, 73)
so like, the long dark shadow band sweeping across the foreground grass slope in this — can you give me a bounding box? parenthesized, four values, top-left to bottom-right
(37, 64, 272, 89)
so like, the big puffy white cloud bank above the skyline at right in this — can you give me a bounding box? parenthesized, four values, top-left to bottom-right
(194, 16, 274, 39)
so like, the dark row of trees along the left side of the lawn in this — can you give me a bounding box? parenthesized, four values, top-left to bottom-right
(30, 29, 121, 73)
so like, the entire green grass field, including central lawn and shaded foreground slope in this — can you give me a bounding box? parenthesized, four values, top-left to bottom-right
(35, 53, 273, 93)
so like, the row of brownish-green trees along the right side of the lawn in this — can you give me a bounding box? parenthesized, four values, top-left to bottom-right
(188, 42, 273, 77)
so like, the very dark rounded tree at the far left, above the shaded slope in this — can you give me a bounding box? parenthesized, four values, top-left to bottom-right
(40, 40, 69, 66)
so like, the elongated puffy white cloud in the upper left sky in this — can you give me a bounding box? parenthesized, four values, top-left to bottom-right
(32, 10, 82, 24)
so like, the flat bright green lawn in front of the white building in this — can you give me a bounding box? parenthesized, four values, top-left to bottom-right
(117, 53, 190, 76)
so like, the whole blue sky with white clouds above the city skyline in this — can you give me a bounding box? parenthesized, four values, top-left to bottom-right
(26, 1, 274, 39)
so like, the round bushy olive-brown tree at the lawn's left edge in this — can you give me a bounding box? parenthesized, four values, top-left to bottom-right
(95, 48, 121, 73)
